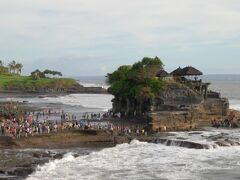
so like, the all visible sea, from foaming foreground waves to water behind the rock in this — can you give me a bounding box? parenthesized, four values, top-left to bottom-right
(1, 75, 240, 180)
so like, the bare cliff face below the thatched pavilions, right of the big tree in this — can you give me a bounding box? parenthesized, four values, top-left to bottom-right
(148, 82, 229, 131)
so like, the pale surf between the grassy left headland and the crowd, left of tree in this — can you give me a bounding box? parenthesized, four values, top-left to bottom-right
(0, 76, 113, 114)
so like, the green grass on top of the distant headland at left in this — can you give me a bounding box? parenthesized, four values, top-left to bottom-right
(0, 75, 76, 90)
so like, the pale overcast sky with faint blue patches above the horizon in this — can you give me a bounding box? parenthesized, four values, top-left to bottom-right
(0, 0, 240, 76)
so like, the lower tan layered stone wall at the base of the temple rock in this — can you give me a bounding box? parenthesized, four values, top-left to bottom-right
(148, 98, 229, 131)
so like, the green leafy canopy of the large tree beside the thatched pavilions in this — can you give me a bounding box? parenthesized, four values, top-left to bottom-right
(107, 57, 163, 101)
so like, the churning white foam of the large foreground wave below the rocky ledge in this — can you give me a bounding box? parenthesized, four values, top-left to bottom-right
(28, 136, 240, 180)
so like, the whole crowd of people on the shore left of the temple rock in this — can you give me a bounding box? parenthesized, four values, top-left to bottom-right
(0, 104, 147, 138)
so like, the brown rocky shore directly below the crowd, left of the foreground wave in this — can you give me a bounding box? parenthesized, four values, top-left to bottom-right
(0, 130, 165, 180)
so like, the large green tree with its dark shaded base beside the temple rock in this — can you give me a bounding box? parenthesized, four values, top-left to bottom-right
(107, 57, 163, 116)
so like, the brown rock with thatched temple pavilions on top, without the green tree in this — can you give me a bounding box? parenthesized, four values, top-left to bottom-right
(148, 66, 229, 131)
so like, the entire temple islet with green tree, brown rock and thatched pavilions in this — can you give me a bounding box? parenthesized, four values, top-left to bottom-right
(107, 57, 229, 131)
